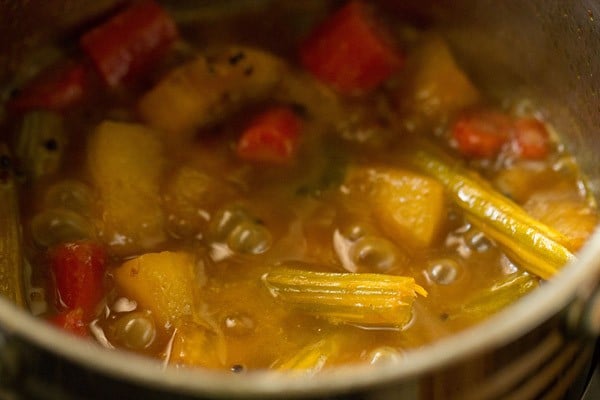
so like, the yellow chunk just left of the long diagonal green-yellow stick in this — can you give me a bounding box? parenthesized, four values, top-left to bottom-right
(347, 167, 446, 248)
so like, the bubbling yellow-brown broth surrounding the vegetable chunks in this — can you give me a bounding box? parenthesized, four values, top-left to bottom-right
(5, 2, 596, 372)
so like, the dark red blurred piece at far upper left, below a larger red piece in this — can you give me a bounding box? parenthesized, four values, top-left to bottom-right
(9, 61, 89, 111)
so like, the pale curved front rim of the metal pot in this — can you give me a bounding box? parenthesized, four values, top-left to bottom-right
(0, 231, 600, 397)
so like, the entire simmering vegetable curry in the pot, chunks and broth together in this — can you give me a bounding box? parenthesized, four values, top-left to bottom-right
(3, 0, 597, 373)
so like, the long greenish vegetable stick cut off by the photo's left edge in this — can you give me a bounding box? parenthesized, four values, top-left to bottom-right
(0, 143, 23, 306)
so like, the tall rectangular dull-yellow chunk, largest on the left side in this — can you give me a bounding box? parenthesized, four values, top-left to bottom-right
(88, 121, 166, 255)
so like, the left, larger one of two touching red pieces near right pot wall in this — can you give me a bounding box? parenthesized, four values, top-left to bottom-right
(452, 111, 514, 158)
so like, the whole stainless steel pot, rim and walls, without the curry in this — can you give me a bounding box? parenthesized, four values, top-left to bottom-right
(0, 0, 600, 399)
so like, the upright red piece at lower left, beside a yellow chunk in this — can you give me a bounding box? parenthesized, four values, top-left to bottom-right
(49, 240, 107, 316)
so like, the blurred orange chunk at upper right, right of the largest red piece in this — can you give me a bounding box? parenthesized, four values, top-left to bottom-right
(397, 35, 480, 126)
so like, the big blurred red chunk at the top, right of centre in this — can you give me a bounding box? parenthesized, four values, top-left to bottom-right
(300, 1, 402, 95)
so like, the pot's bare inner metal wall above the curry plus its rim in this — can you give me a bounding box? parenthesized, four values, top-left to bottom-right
(0, 0, 600, 397)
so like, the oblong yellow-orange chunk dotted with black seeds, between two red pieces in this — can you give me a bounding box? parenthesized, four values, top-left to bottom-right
(138, 47, 285, 137)
